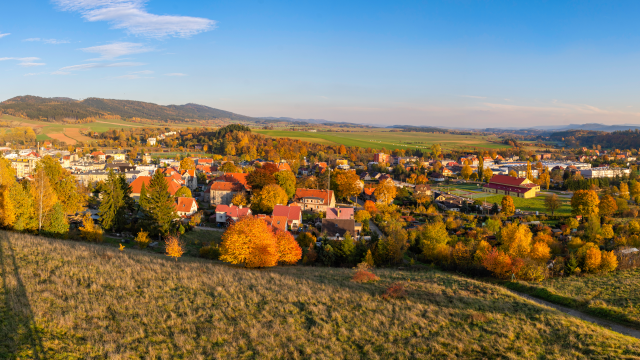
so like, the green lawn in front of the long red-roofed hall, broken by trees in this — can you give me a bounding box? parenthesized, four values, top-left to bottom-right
(434, 184, 571, 215)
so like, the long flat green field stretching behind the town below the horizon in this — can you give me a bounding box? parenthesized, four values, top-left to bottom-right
(254, 129, 508, 150)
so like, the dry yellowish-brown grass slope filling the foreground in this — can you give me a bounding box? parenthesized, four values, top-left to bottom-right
(0, 232, 640, 359)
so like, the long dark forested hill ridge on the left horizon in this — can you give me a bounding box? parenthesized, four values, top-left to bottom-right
(0, 95, 259, 122)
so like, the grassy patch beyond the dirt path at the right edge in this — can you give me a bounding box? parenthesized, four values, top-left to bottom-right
(505, 269, 640, 329)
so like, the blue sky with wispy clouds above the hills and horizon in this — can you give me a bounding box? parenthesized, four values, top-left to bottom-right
(0, 0, 640, 128)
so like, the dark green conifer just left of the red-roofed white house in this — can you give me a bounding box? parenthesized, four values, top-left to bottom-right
(143, 172, 177, 235)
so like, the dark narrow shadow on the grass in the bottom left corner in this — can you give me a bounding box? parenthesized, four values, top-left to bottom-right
(0, 239, 46, 359)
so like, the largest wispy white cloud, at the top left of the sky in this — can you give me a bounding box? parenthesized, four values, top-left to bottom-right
(53, 0, 216, 38)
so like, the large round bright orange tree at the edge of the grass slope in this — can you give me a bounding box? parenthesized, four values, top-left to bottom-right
(220, 216, 278, 267)
